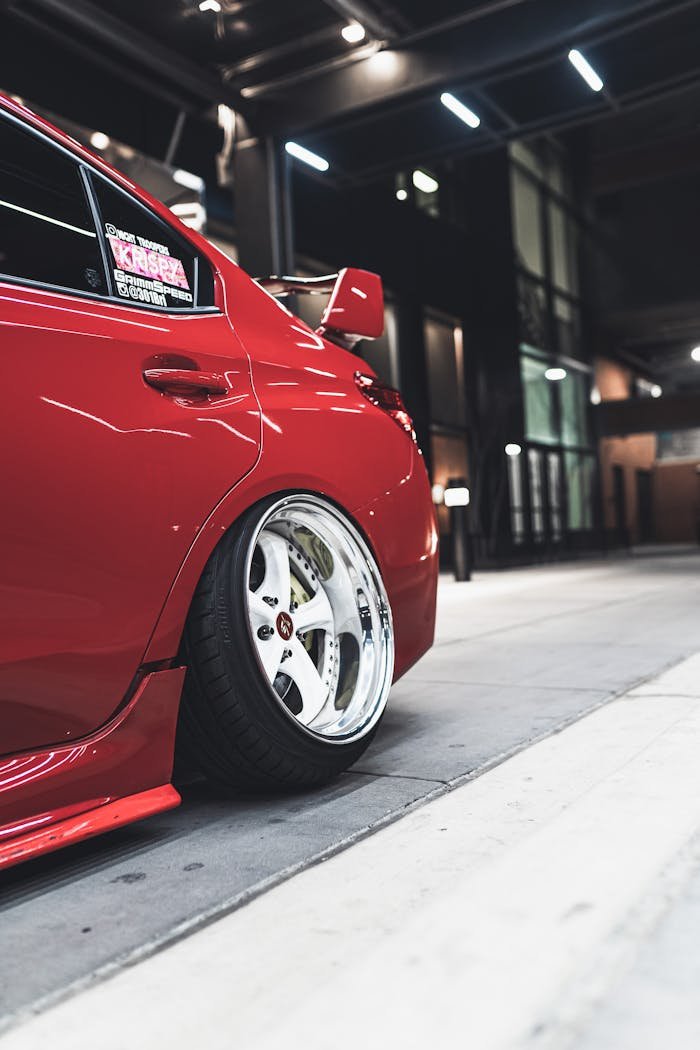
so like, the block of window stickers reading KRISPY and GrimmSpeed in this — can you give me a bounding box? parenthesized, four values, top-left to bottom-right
(105, 223, 193, 307)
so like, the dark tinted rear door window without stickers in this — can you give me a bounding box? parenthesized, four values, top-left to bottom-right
(0, 118, 107, 294)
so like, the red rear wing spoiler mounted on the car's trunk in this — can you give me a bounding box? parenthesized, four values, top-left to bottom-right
(257, 267, 384, 350)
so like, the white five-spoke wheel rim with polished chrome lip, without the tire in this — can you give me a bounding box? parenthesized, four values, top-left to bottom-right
(247, 496, 394, 740)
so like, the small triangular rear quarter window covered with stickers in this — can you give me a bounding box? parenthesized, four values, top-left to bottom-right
(92, 176, 214, 310)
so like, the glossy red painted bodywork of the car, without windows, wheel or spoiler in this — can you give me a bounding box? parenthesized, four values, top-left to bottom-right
(0, 98, 437, 867)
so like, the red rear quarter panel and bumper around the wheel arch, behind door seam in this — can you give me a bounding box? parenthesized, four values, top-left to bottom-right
(146, 262, 438, 676)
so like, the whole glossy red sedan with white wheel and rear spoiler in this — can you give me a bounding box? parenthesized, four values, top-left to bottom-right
(0, 98, 438, 867)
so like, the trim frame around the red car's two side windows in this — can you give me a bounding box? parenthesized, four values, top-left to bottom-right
(0, 107, 221, 316)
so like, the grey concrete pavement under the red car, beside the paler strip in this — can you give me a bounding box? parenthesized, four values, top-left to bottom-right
(0, 552, 700, 1037)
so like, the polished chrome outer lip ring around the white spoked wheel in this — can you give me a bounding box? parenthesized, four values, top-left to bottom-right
(243, 491, 395, 746)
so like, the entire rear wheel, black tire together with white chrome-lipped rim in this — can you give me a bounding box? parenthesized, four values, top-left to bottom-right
(178, 494, 394, 791)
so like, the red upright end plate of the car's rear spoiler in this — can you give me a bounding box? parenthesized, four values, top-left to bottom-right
(317, 268, 384, 350)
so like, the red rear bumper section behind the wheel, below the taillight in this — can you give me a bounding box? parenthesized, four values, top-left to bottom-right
(355, 450, 439, 681)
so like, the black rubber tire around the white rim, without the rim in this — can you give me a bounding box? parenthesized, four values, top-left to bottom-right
(177, 497, 392, 793)
